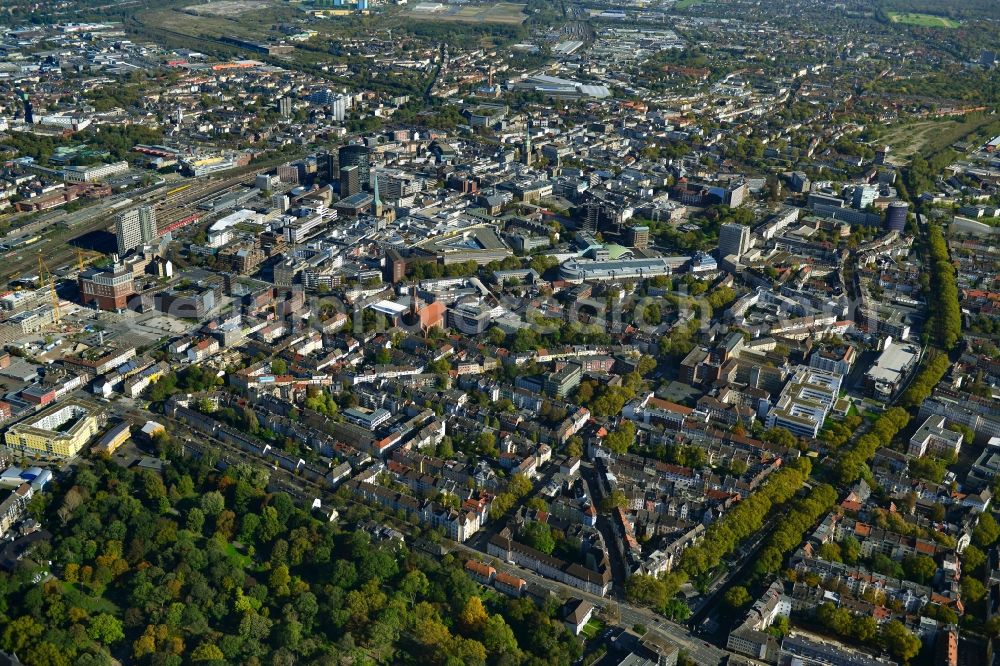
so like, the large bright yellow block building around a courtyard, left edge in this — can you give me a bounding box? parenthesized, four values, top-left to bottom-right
(4, 400, 100, 458)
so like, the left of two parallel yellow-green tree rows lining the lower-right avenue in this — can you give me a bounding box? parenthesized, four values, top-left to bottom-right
(679, 457, 812, 578)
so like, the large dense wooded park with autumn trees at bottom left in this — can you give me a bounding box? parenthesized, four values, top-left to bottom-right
(0, 459, 581, 666)
